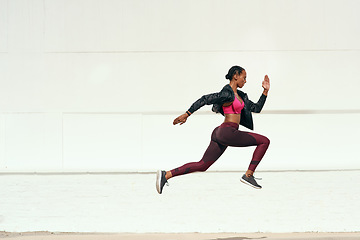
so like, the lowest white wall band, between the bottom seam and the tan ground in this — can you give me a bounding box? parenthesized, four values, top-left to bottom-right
(0, 171, 360, 233)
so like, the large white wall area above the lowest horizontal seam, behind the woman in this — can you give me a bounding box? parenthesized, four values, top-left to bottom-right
(0, 0, 360, 172)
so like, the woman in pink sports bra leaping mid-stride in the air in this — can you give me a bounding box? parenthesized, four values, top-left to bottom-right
(156, 66, 270, 194)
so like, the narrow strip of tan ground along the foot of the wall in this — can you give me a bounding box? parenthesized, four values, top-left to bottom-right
(0, 232, 360, 240)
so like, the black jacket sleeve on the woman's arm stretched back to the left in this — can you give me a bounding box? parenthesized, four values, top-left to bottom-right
(188, 91, 232, 114)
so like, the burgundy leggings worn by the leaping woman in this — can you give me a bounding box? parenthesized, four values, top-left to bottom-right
(171, 122, 270, 177)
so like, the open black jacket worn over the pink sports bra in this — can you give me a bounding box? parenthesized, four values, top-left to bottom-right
(188, 84, 266, 130)
